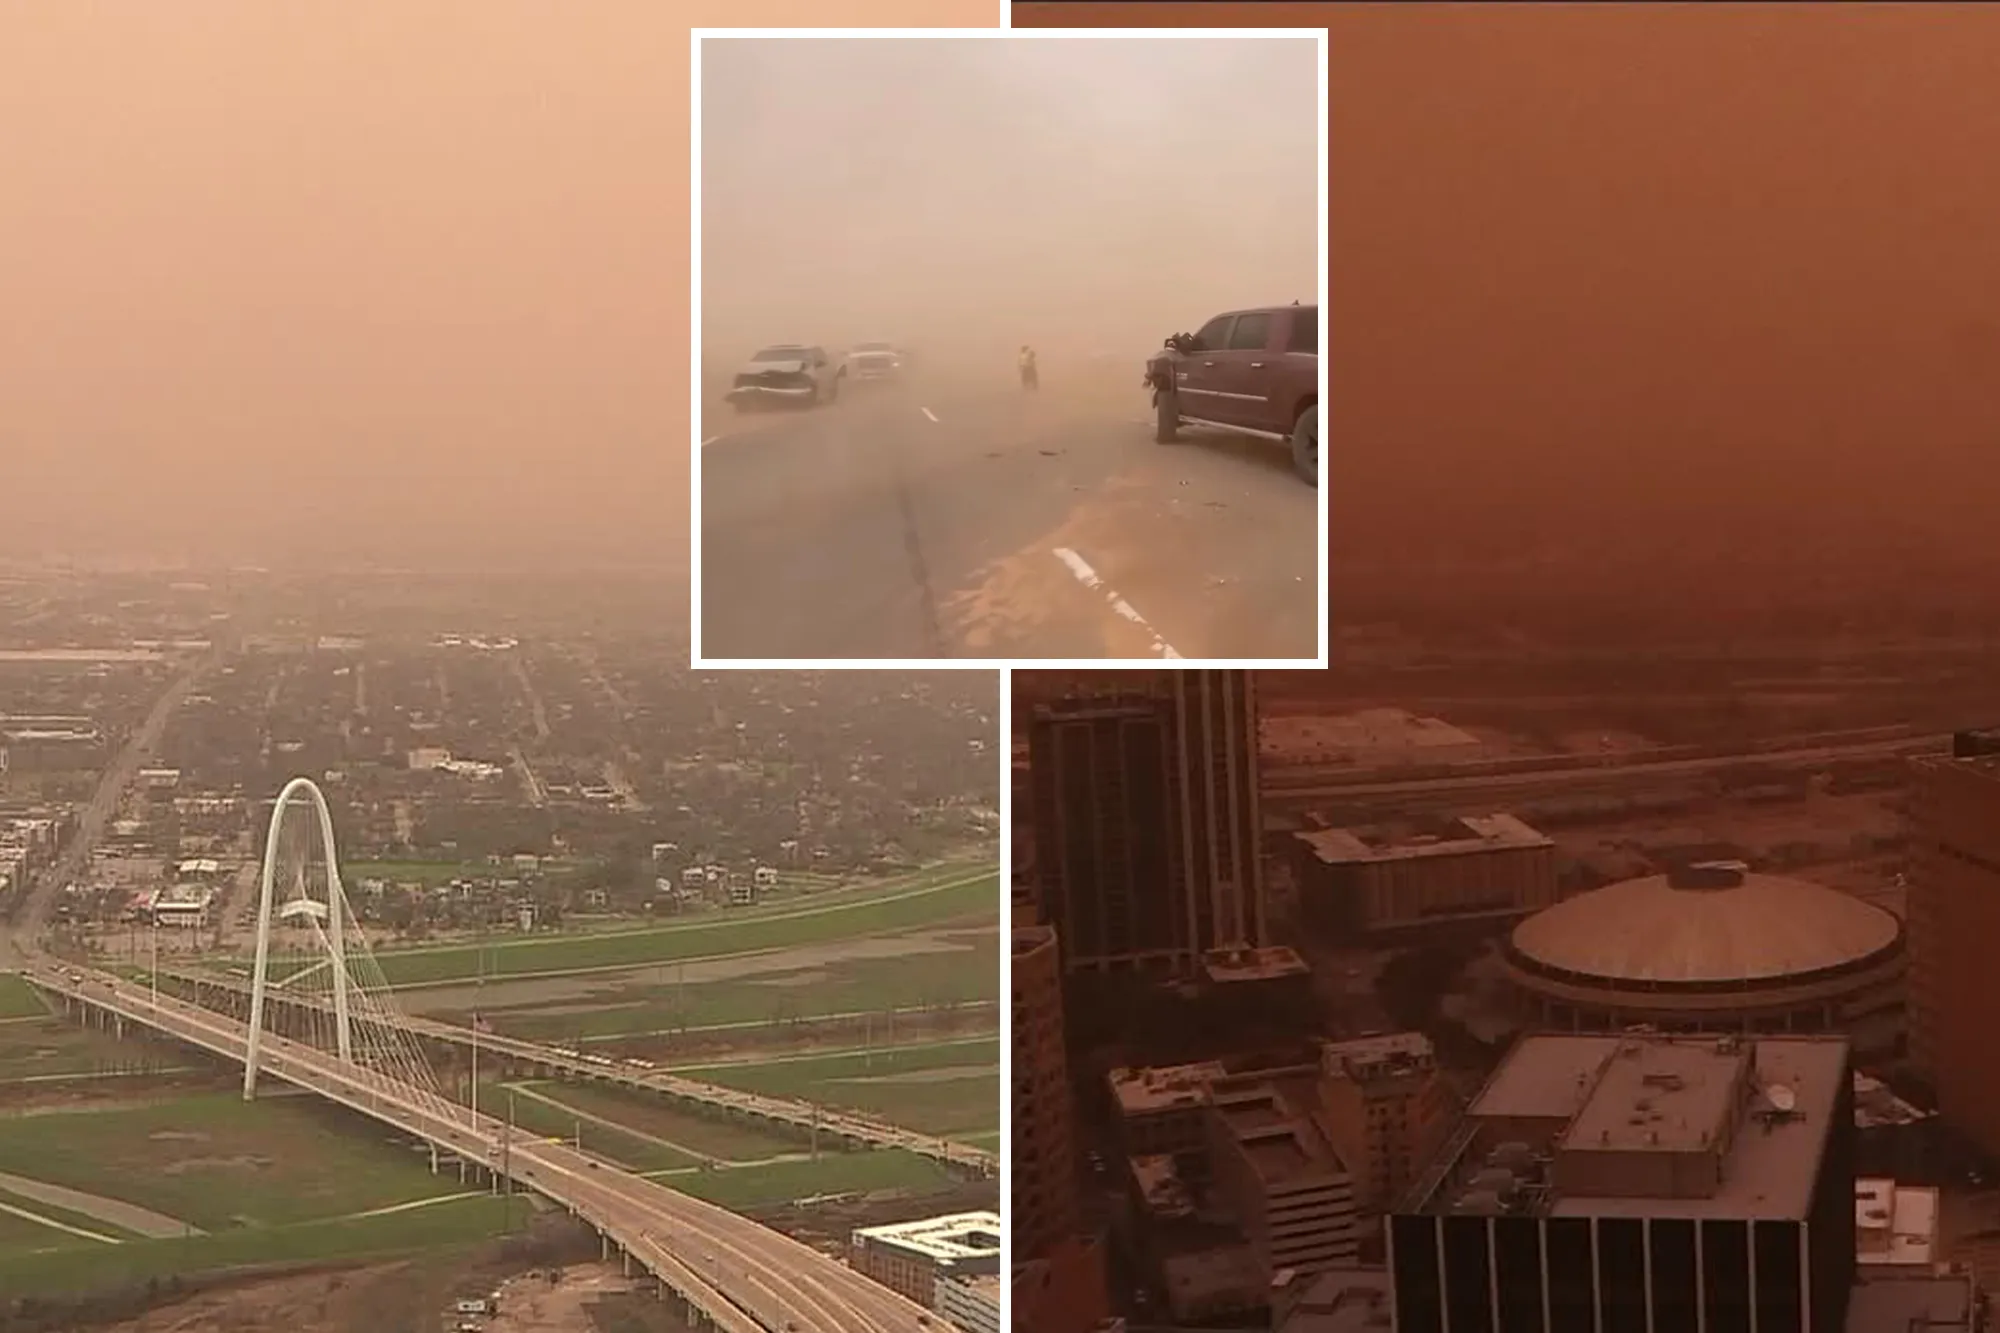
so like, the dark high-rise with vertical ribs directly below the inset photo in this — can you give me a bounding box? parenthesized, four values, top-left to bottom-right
(1028, 671, 1266, 973)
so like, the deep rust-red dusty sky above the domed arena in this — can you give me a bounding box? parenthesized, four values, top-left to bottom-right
(1328, 4, 2000, 632)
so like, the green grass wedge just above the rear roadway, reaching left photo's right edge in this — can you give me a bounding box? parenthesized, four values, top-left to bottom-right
(676, 1037, 1000, 1137)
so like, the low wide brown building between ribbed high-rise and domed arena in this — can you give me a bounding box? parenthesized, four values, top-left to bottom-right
(1294, 815, 1556, 937)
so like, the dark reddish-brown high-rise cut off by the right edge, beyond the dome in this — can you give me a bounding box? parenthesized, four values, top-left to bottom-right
(1906, 731, 2000, 1153)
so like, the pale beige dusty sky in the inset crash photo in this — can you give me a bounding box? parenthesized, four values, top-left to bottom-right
(700, 36, 1320, 384)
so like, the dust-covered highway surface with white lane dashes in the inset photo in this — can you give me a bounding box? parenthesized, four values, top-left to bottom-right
(700, 364, 1322, 660)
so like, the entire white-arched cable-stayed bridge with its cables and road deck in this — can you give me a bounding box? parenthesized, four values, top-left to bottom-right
(26, 779, 948, 1333)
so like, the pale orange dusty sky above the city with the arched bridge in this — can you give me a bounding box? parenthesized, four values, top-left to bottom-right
(0, 0, 686, 564)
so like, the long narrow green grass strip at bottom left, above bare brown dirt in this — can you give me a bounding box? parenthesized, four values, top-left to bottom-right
(0, 1195, 534, 1297)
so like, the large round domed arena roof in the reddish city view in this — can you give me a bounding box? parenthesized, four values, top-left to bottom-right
(1512, 863, 1902, 989)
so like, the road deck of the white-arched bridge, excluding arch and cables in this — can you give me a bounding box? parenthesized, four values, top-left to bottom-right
(30, 967, 950, 1333)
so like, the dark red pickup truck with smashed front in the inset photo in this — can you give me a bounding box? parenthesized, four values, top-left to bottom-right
(1146, 302, 1320, 486)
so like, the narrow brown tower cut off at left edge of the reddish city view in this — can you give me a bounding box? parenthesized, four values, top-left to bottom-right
(1008, 917, 1080, 1263)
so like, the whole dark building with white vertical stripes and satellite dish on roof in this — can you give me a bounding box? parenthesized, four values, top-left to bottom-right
(1388, 1035, 1856, 1333)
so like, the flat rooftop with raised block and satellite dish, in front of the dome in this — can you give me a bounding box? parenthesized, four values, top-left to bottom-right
(1406, 1033, 1850, 1219)
